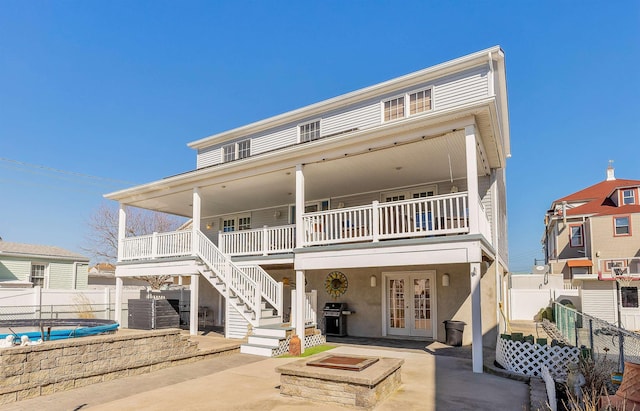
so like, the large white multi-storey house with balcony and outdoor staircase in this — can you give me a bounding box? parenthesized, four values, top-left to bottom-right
(106, 47, 510, 372)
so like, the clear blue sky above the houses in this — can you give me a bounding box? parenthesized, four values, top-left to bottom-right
(0, 0, 640, 271)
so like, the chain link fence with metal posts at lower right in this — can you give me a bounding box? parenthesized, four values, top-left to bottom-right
(553, 303, 640, 372)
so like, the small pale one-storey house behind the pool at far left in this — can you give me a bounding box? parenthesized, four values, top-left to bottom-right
(0, 241, 89, 289)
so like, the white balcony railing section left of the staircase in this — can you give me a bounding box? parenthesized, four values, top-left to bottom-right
(120, 230, 192, 261)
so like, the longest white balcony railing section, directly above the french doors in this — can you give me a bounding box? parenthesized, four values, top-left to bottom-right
(302, 192, 472, 246)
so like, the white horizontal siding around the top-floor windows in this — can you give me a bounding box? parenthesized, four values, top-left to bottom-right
(197, 65, 489, 168)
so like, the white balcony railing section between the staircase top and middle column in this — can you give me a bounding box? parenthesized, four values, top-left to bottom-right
(218, 225, 295, 256)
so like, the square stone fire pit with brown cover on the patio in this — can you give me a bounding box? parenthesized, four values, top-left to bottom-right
(276, 355, 404, 408)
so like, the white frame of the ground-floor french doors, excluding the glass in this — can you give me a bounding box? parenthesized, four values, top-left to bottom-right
(382, 270, 438, 340)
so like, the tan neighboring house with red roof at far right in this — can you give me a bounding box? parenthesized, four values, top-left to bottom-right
(543, 166, 640, 330)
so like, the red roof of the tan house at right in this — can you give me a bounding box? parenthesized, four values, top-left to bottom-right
(554, 179, 640, 216)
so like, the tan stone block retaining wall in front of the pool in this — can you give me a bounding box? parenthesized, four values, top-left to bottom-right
(0, 329, 237, 404)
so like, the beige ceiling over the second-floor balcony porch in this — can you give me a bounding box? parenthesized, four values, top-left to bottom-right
(122, 131, 484, 218)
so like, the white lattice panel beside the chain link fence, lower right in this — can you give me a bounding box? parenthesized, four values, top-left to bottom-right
(496, 338, 580, 381)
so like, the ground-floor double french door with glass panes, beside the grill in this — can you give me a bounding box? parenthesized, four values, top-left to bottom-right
(384, 271, 436, 338)
